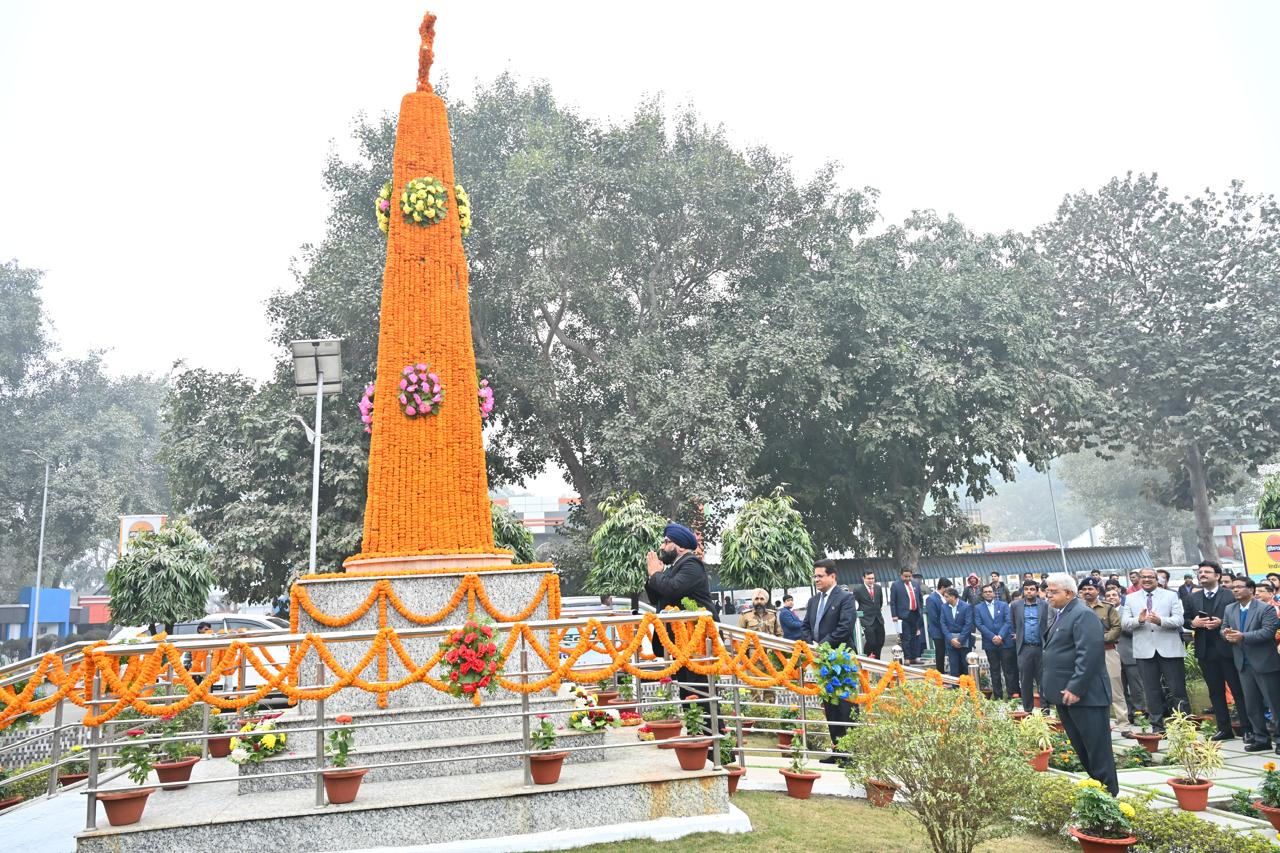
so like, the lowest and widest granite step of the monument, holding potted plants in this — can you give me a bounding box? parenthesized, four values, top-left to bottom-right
(77, 730, 730, 853)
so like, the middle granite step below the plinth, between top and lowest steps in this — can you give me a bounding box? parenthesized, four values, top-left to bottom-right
(239, 731, 605, 794)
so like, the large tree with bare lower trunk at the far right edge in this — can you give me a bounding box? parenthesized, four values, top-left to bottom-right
(1038, 173, 1280, 557)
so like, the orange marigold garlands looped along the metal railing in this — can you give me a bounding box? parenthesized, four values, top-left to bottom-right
(0, 607, 978, 729)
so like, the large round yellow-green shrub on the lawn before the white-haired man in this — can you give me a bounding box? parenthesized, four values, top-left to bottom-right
(840, 681, 1037, 853)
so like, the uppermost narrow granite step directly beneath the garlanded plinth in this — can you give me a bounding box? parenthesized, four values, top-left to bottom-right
(267, 695, 573, 747)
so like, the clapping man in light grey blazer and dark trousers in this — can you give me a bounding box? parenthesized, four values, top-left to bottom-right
(1120, 569, 1190, 731)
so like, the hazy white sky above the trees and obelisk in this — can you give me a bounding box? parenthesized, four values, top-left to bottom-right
(0, 0, 1280, 377)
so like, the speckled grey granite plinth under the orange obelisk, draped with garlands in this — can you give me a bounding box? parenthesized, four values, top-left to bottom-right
(298, 569, 552, 716)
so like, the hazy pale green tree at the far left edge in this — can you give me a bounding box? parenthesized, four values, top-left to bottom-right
(0, 263, 168, 599)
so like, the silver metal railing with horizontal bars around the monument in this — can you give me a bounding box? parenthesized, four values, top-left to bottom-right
(0, 611, 956, 830)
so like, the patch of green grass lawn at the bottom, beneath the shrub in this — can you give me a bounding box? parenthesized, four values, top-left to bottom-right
(560, 792, 1075, 853)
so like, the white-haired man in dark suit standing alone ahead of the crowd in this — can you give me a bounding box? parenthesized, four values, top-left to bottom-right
(1043, 573, 1120, 797)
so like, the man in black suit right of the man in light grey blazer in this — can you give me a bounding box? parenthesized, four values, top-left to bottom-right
(1178, 560, 1244, 745)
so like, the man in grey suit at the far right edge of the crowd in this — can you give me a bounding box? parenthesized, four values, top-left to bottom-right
(1222, 578, 1280, 754)
